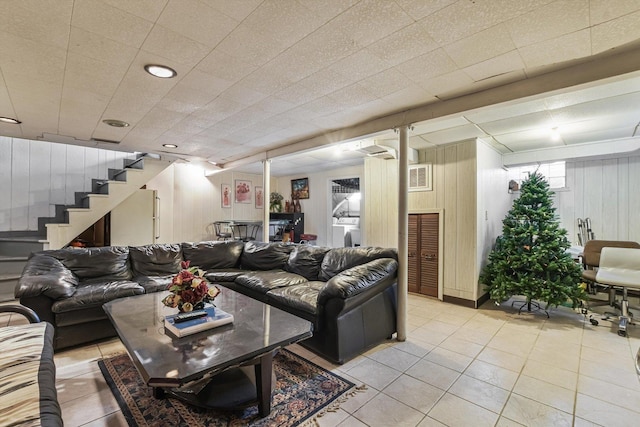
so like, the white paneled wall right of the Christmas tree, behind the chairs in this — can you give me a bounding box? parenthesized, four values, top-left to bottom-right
(555, 156, 640, 244)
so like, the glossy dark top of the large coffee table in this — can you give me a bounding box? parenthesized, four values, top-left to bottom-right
(103, 287, 312, 387)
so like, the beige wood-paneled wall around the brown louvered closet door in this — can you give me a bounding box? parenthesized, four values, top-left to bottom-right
(365, 140, 508, 300)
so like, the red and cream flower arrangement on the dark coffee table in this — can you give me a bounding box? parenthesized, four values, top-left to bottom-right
(162, 261, 220, 312)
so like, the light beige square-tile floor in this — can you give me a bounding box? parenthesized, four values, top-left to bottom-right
(0, 295, 640, 427)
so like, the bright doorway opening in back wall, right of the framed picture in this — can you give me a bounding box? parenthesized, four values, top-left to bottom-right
(331, 177, 362, 248)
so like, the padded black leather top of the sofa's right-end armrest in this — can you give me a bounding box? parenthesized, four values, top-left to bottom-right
(318, 258, 398, 306)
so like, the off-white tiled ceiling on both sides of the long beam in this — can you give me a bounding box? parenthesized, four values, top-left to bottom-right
(0, 0, 640, 174)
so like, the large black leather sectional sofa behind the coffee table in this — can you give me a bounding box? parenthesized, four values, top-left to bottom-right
(15, 241, 398, 363)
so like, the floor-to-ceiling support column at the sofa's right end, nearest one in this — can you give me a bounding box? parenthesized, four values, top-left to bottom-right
(397, 125, 409, 341)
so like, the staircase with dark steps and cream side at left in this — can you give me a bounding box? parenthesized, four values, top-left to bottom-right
(0, 155, 172, 302)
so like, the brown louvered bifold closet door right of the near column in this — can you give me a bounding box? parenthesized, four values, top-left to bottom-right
(408, 214, 439, 297)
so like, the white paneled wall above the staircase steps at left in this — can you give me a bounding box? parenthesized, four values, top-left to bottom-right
(0, 137, 131, 231)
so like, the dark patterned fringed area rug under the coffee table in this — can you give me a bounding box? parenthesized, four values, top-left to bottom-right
(98, 350, 359, 427)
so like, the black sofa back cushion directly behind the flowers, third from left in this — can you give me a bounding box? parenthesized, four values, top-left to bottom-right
(182, 240, 244, 270)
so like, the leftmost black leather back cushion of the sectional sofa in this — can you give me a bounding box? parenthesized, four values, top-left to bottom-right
(46, 246, 131, 281)
